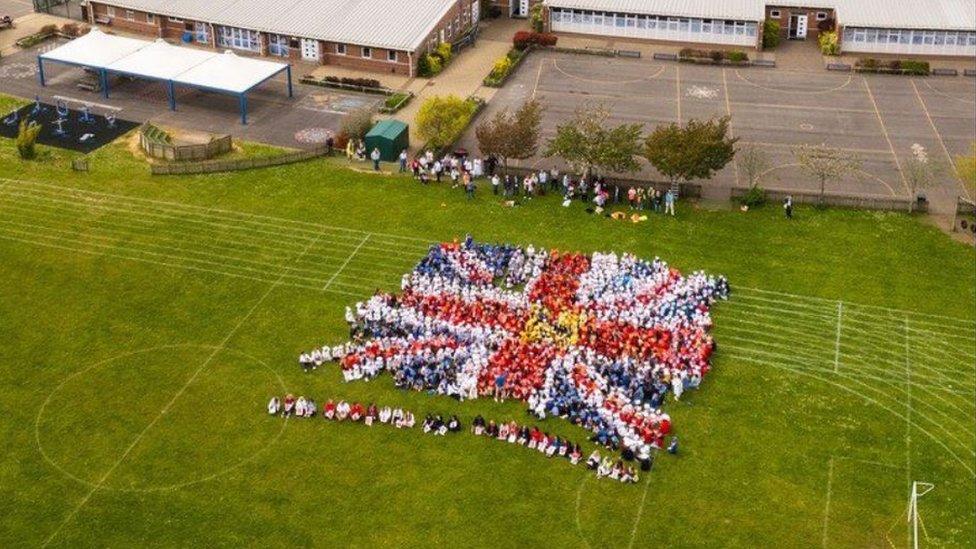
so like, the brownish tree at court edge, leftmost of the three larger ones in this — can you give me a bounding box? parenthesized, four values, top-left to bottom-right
(475, 99, 543, 170)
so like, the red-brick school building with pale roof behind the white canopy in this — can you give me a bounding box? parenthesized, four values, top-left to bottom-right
(88, 0, 481, 76)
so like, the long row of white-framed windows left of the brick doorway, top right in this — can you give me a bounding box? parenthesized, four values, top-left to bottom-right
(551, 8, 757, 36)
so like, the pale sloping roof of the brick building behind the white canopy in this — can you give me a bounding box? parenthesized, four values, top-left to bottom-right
(92, 0, 458, 51)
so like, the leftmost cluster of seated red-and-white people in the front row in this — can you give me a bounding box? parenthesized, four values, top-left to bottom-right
(268, 393, 417, 429)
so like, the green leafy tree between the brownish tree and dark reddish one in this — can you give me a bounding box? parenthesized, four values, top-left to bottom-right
(543, 105, 643, 178)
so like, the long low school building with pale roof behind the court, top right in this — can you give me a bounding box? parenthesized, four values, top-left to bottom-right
(543, 0, 976, 57)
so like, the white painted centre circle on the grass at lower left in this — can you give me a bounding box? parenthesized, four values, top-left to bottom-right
(34, 343, 288, 493)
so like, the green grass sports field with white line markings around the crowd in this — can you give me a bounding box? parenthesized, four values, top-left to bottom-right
(0, 107, 976, 548)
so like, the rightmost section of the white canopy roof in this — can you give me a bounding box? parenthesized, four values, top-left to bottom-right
(172, 48, 287, 93)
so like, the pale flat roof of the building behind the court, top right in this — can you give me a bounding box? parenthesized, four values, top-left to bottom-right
(545, 0, 976, 30)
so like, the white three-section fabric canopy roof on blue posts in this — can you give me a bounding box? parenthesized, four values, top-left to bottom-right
(38, 29, 288, 93)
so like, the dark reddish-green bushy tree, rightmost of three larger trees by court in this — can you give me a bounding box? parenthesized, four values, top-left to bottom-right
(644, 116, 739, 185)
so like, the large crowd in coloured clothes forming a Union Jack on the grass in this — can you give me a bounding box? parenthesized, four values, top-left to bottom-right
(300, 238, 729, 470)
